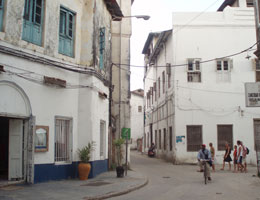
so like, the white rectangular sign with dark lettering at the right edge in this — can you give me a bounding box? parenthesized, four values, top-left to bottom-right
(245, 82, 260, 107)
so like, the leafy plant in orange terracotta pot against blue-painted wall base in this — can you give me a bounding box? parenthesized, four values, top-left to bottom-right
(78, 141, 95, 180)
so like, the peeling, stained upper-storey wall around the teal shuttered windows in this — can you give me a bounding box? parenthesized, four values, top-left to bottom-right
(0, 0, 111, 73)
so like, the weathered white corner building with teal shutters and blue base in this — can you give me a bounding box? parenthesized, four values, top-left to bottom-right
(0, 0, 122, 183)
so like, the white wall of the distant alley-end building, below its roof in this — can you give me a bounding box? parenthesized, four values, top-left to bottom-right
(130, 93, 144, 149)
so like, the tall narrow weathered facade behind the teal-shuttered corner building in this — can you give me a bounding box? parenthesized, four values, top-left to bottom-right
(110, 0, 134, 166)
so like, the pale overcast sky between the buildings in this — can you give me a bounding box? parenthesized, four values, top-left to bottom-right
(131, 0, 224, 91)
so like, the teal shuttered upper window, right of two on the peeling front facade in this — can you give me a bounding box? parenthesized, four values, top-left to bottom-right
(59, 7, 75, 57)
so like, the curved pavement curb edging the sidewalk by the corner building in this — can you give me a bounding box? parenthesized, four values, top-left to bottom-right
(83, 178, 149, 200)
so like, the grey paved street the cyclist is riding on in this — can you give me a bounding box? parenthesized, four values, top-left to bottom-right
(112, 151, 260, 200)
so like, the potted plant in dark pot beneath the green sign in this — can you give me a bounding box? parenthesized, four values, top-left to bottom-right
(113, 138, 125, 177)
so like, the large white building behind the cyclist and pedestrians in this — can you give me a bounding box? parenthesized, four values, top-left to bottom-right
(143, 0, 260, 164)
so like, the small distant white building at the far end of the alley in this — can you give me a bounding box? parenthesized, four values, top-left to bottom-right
(130, 89, 144, 151)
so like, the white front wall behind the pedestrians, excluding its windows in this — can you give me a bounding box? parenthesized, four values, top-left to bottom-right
(172, 5, 260, 163)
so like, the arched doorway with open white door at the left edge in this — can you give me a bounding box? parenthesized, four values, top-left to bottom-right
(0, 81, 34, 182)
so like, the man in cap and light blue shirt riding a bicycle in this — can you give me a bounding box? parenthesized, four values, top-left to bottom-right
(197, 144, 211, 181)
